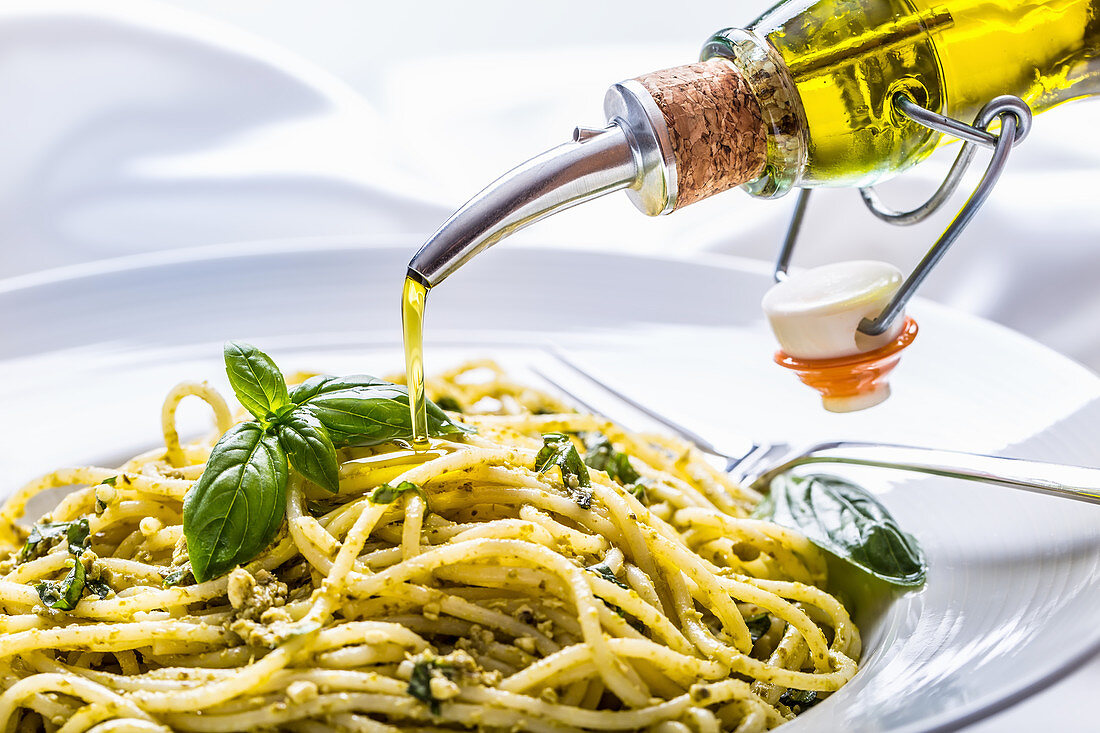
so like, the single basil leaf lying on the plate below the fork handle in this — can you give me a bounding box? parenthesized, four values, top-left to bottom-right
(754, 474, 927, 586)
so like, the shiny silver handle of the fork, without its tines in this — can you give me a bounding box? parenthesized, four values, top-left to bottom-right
(761, 441, 1100, 504)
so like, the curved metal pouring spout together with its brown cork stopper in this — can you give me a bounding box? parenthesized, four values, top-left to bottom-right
(408, 58, 768, 287)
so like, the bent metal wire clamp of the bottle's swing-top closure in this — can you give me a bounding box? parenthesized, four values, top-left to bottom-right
(774, 92, 1032, 336)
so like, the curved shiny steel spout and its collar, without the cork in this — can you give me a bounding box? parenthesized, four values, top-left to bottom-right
(409, 81, 677, 287)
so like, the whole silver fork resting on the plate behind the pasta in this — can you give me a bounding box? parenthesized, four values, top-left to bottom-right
(532, 351, 1100, 504)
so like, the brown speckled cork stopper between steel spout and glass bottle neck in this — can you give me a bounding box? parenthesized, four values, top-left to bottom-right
(637, 58, 768, 209)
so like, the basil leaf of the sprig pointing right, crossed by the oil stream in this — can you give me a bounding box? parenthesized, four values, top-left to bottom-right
(301, 384, 474, 448)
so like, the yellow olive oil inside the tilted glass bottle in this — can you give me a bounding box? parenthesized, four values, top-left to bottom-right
(734, 0, 1100, 186)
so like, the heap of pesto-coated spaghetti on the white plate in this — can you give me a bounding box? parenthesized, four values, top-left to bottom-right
(0, 362, 860, 733)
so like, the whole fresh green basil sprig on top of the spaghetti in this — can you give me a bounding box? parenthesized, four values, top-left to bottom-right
(184, 341, 473, 582)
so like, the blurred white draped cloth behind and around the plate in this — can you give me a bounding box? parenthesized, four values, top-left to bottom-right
(0, 0, 1100, 731)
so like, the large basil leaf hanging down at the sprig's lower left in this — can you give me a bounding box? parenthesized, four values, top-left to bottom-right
(184, 423, 287, 582)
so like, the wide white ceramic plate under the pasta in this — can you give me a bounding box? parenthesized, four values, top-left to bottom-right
(0, 236, 1100, 733)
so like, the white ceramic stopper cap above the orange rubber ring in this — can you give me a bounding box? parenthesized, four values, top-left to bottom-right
(761, 260, 905, 359)
